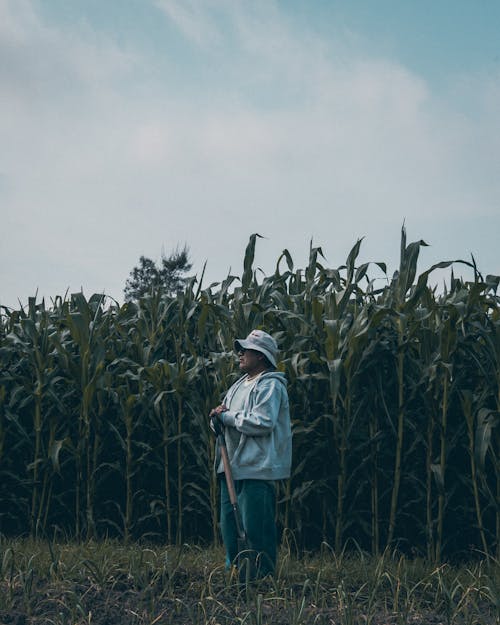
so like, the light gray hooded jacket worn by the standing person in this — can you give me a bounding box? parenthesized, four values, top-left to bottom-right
(215, 371, 292, 480)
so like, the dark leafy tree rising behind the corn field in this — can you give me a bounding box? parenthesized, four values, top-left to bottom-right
(123, 245, 192, 302)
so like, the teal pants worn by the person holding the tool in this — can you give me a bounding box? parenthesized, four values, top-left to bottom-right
(220, 475, 276, 577)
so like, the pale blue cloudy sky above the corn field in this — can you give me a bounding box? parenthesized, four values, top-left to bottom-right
(0, 0, 500, 308)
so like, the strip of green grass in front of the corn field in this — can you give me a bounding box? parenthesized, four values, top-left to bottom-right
(0, 539, 500, 625)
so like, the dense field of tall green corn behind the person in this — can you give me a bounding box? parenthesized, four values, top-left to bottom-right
(0, 230, 500, 561)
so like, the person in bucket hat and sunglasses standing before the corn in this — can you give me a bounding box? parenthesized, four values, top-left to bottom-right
(210, 330, 292, 577)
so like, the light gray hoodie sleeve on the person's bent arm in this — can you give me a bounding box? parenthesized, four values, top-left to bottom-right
(222, 379, 284, 436)
